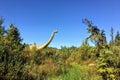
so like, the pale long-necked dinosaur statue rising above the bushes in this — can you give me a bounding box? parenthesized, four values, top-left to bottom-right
(29, 30, 58, 49)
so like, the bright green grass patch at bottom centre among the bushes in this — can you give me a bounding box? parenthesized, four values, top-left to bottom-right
(47, 64, 101, 80)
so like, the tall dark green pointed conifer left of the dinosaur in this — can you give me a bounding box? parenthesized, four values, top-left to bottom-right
(6, 24, 23, 79)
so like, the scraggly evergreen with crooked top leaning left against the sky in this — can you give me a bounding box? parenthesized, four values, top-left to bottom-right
(83, 19, 107, 48)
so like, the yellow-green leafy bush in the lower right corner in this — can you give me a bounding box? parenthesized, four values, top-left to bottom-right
(97, 46, 120, 80)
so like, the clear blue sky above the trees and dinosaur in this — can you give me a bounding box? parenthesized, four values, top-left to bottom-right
(0, 0, 120, 48)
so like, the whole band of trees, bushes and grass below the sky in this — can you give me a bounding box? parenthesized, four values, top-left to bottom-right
(0, 18, 120, 80)
